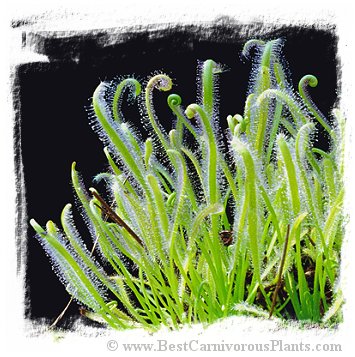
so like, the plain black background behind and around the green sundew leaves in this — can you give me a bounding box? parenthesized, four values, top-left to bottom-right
(14, 21, 339, 325)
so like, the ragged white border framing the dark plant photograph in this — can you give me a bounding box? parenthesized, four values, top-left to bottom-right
(0, 0, 355, 356)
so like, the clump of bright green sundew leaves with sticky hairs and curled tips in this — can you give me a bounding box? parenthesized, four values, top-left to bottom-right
(31, 39, 345, 330)
